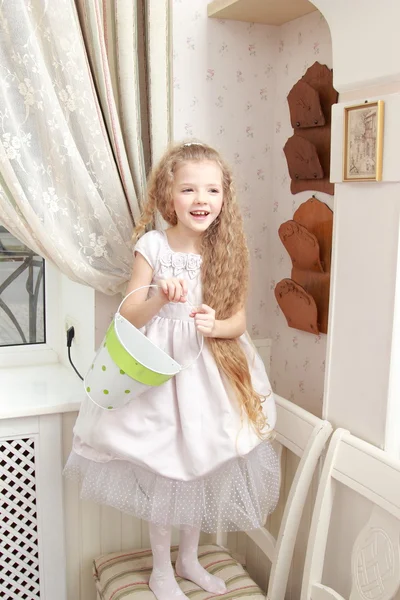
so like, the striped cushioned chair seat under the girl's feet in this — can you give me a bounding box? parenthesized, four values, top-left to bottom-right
(93, 545, 265, 600)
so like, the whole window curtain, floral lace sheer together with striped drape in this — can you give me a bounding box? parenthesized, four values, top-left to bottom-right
(0, 0, 166, 293)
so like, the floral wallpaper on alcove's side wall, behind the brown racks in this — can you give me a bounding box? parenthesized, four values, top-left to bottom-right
(267, 12, 333, 415)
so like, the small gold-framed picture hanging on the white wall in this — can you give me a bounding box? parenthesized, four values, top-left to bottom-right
(343, 100, 384, 181)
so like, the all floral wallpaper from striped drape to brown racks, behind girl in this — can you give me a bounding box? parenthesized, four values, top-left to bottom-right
(172, 0, 333, 414)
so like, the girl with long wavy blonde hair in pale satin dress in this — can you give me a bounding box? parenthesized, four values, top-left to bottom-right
(66, 142, 279, 600)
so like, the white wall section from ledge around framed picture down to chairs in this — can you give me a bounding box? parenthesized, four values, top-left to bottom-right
(324, 93, 400, 447)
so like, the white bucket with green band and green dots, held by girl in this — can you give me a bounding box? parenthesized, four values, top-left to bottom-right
(84, 285, 204, 410)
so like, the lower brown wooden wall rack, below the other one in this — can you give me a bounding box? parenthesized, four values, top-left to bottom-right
(275, 196, 333, 334)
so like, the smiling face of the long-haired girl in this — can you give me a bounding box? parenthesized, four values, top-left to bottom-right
(172, 160, 223, 234)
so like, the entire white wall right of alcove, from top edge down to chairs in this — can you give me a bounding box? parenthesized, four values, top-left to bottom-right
(314, 0, 400, 451)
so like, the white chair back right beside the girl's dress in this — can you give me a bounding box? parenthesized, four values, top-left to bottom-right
(246, 395, 332, 600)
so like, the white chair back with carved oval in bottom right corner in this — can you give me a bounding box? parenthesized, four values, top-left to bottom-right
(301, 429, 400, 600)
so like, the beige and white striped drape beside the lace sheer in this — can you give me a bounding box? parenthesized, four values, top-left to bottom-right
(75, 0, 150, 219)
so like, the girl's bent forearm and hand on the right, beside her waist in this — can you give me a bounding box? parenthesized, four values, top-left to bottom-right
(191, 304, 246, 339)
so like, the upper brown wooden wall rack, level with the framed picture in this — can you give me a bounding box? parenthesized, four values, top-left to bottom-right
(283, 62, 338, 194)
